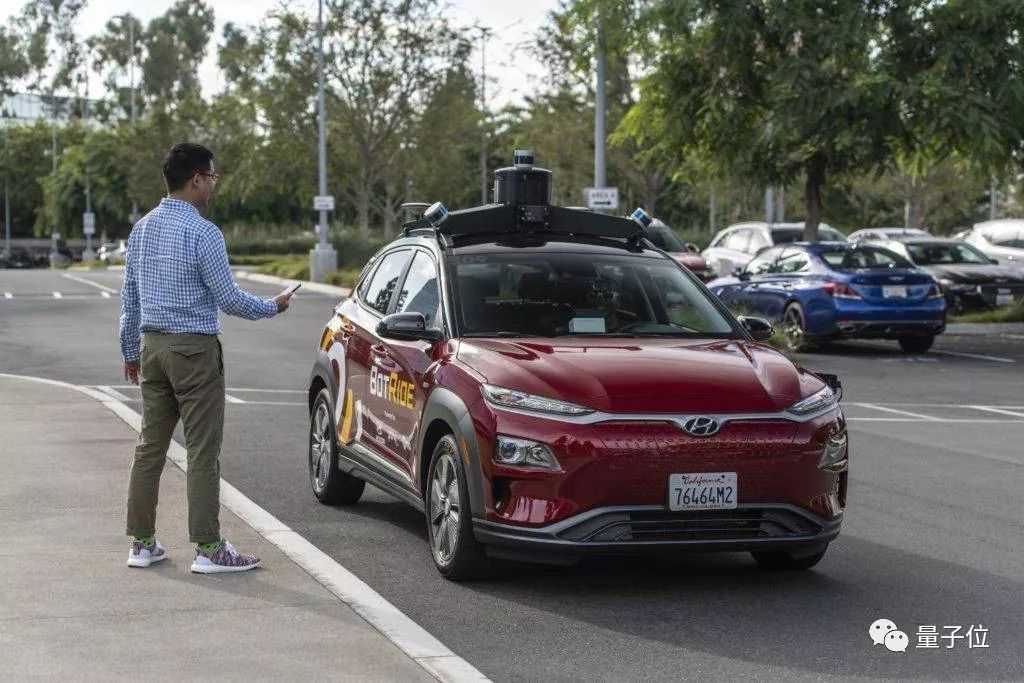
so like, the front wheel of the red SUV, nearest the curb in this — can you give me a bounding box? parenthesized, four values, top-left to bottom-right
(424, 434, 486, 581)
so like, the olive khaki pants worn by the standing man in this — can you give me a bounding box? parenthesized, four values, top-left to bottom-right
(127, 332, 224, 544)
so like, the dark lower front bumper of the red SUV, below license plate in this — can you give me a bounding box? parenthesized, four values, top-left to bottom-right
(473, 504, 843, 561)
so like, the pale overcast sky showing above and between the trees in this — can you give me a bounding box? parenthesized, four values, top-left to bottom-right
(0, 0, 558, 109)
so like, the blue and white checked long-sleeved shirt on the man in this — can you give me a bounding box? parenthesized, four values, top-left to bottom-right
(120, 199, 278, 362)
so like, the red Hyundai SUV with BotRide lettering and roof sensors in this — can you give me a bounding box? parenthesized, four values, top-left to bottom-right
(309, 157, 848, 580)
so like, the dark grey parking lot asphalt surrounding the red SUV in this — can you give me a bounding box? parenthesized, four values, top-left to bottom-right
(0, 270, 1024, 680)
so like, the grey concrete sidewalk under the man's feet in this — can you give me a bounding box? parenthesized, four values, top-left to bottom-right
(0, 378, 433, 681)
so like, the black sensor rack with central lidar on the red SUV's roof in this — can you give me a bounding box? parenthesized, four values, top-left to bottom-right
(403, 150, 652, 246)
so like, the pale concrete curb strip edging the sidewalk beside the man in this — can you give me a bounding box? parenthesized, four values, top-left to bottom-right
(0, 373, 488, 681)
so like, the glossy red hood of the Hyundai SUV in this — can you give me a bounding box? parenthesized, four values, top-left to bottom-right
(457, 338, 824, 414)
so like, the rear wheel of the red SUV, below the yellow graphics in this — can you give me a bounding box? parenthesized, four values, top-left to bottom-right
(308, 389, 367, 505)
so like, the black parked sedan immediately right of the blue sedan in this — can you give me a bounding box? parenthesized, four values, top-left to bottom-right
(872, 237, 1024, 315)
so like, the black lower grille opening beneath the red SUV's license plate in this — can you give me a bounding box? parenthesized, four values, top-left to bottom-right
(558, 508, 821, 543)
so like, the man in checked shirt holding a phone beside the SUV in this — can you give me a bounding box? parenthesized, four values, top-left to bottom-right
(120, 142, 292, 573)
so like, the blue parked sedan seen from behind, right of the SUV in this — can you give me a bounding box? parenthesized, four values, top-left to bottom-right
(708, 242, 946, 353)
